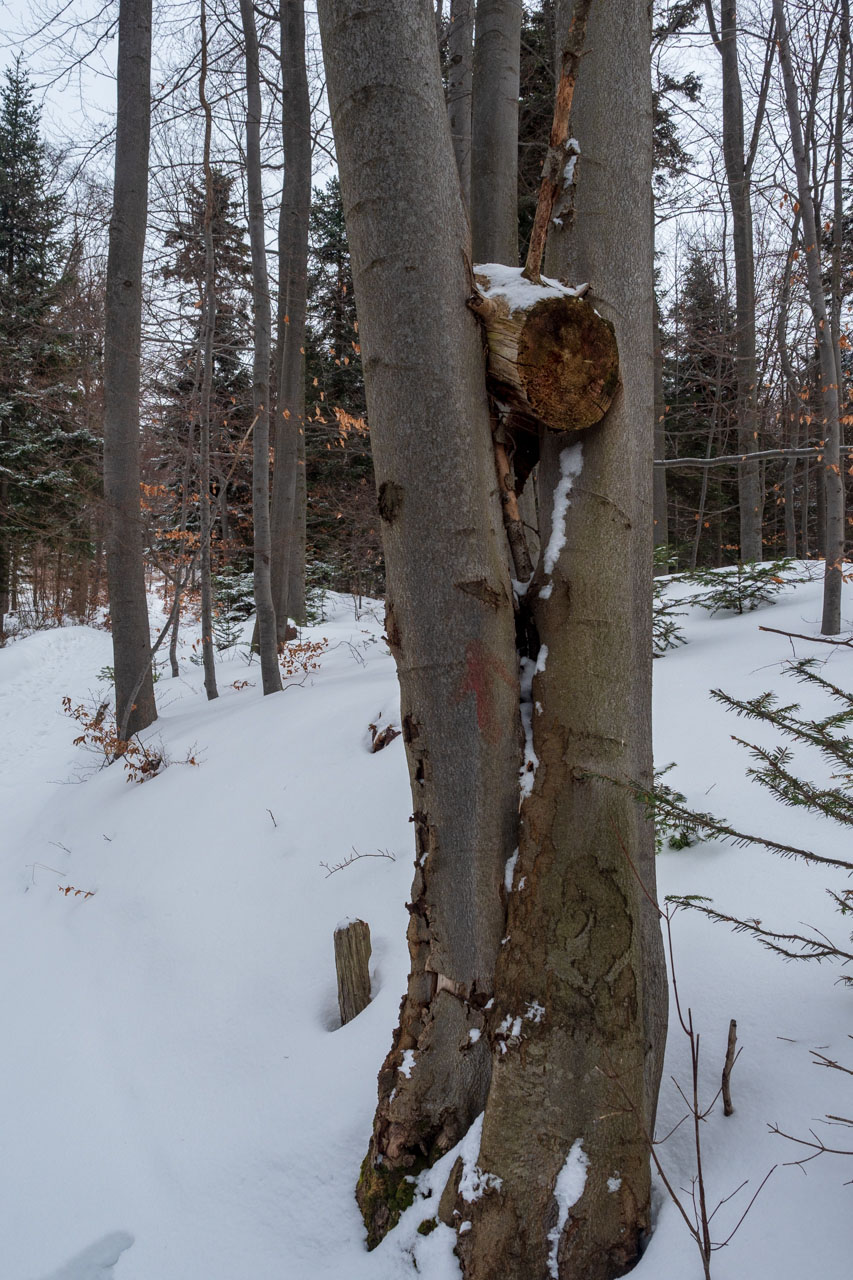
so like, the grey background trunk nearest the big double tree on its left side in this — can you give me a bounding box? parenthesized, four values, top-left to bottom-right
(272, 0, 311, 643)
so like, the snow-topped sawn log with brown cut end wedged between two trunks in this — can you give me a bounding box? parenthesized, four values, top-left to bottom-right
(470, 264, 619, 431)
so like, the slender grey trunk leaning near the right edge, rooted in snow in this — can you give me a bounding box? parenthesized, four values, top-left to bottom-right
(774, 0, 844, 635)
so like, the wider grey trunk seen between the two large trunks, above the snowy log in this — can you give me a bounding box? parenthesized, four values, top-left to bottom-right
(471, 0, 521, 266)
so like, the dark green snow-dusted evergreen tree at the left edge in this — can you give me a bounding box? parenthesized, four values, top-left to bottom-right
(0, 59, 97, 630)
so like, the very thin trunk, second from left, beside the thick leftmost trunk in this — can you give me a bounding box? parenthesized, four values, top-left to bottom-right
(198, 0, 219, 700)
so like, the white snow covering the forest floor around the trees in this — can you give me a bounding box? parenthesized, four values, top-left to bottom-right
(0, 582, 853, 1280)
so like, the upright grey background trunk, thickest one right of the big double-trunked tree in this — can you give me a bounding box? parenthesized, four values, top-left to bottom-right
(706, 0, 770, 561)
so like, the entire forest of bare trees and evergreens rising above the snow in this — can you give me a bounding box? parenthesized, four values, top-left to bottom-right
(0, 0, 853, 1280)
